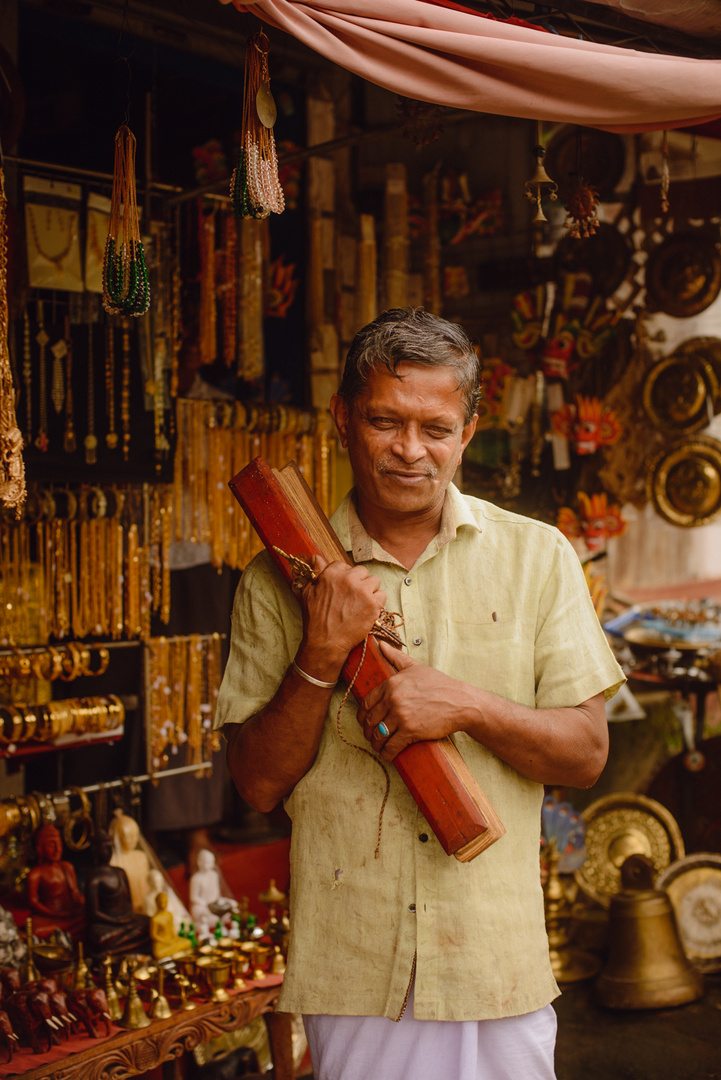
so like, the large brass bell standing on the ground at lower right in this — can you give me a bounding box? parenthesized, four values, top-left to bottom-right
(596, 854, 704, 1009)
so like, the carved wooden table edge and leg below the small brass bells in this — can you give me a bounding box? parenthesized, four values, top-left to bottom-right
(5, 980, 294, 1080)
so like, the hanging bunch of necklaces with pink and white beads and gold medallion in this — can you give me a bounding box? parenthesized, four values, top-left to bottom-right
(230, 30, 285, 217)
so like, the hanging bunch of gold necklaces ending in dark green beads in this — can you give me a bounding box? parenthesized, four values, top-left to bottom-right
(103, 124, 150, 315)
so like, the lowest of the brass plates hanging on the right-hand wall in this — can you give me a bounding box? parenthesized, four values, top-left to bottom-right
(648, 435, 721, 528)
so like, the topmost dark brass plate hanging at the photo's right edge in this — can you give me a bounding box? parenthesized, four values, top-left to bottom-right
(645, 232, 721, 319)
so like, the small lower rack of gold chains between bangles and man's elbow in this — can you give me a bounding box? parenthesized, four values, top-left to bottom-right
(145, 634, 222, 775)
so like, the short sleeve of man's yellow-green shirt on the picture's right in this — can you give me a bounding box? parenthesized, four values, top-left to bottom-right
(534, 532, 626, 708)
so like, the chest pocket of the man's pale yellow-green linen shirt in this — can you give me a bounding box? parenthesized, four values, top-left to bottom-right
(443, 617, 535, 705)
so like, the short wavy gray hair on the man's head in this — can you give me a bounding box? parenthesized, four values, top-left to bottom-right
(338, 308, 480, 423)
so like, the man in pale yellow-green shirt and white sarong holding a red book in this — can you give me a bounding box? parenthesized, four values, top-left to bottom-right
(216, 310, 623, 1080)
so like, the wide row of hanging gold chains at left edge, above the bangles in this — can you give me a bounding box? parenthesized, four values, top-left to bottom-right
(0, 485, 173, 646)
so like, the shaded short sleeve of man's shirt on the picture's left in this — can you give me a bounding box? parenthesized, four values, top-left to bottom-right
(214, 552, 302, 728)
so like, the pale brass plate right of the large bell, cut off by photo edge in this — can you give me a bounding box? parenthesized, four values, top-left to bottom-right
(656, 852, 721, 972)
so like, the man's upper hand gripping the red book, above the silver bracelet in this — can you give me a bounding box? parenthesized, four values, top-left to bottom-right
(296, 555, 385, 679)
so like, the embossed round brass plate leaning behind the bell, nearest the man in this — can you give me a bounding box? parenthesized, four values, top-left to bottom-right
(574, 792, 684, 907)
